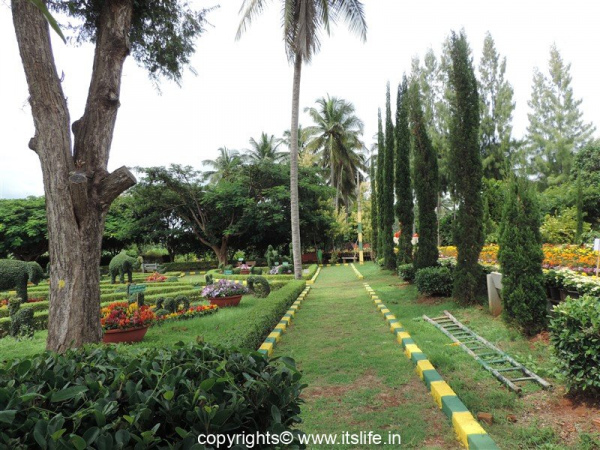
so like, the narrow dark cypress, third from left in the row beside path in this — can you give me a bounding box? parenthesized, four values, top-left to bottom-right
(395, 76, 414, 265)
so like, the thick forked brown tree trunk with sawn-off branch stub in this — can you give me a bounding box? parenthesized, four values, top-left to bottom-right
(12, 0, 135, 352)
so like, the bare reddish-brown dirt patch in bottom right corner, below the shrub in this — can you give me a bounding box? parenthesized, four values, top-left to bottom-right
(517, 387, 600, 446)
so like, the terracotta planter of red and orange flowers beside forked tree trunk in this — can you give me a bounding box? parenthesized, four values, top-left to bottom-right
(100, 302, 156, 343)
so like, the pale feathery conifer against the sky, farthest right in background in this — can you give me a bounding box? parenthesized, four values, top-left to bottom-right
(526, 45, 595, 187)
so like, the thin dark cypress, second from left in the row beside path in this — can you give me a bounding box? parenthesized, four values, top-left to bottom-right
(382, 82, 396, 270)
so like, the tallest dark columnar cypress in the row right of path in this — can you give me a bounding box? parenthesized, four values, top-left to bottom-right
(449, 32, 484, 304)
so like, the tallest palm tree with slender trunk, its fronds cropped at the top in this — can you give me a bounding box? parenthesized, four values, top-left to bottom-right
(236, 0, 367, 279)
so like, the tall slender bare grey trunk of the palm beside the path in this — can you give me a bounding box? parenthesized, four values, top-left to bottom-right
(290, 54, 302, 280)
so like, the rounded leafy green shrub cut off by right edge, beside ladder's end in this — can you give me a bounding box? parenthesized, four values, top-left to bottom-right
(550, 295, 600, 395)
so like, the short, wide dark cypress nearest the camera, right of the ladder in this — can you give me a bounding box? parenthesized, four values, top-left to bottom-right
(498, 180, 547, 336)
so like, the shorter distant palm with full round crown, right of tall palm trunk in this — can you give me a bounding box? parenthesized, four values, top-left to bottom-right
(304, 95, 365, 210)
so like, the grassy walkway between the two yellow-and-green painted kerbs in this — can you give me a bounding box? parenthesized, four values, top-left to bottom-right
(275, 266, 459, 449)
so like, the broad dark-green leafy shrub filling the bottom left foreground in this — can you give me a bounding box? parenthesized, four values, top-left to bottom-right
(0, 344, 303, 448)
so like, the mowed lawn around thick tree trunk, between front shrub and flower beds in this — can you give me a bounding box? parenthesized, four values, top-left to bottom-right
(0, 287, 304, 362)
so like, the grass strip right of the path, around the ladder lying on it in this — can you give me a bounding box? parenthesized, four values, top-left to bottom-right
(360, 264, 600, 449)
